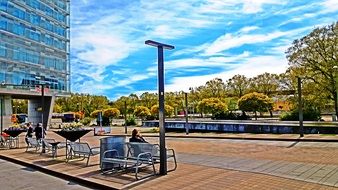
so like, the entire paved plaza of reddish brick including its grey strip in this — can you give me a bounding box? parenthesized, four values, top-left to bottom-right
(0, 128, 338, 189)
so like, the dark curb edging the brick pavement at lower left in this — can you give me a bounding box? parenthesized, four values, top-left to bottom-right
(0, 154, 118, 190)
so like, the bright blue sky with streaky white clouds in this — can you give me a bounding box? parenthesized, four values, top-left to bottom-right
(71, 0, 338, 100)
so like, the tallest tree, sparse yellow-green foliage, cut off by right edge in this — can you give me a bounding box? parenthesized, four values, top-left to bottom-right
(286, 22, 338, 115)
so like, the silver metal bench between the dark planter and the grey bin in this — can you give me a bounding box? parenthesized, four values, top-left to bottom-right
(67, 142, 100, 166)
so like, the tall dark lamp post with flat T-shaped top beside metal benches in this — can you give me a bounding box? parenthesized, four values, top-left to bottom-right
(145, 40, 175, 175)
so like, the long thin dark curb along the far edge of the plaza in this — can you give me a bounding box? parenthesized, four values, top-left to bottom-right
(103, 134, 338, 142)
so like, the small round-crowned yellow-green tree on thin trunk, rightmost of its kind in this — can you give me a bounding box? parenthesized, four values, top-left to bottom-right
(238, 92, 273, 120)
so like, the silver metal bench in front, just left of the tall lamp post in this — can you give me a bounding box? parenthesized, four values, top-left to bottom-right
(101, 143, 156, 180)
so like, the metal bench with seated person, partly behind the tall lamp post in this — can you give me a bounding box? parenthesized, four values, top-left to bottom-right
(126, 142, 177, 172)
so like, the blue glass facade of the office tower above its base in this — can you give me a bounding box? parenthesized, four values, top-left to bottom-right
(0, 0, 70, 94)
